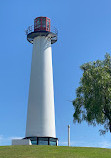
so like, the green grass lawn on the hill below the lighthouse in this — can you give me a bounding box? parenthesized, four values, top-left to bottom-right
(0, 145, 111, 158)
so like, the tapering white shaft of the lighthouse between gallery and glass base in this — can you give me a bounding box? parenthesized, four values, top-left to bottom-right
(26, 36, 56, 137)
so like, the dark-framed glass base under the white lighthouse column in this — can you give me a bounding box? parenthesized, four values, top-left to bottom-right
(24, 137, 58, 146)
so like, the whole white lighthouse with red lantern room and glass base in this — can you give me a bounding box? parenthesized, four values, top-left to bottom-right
(25, 17, 58, 145)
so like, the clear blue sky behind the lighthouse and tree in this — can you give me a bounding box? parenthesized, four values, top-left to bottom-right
(0, 0, 111, 148)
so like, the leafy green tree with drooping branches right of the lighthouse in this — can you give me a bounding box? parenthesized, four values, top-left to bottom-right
(73, 53, 111, 134)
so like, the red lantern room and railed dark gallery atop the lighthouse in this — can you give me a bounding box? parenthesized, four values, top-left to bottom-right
(25, 17, 58, 44)
